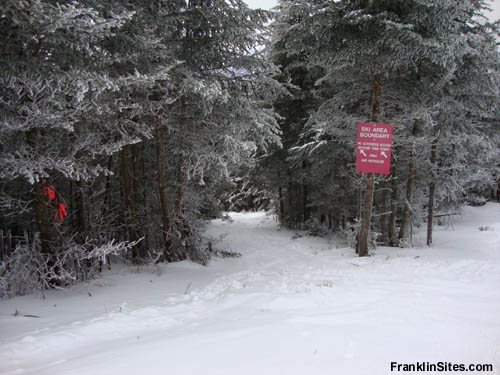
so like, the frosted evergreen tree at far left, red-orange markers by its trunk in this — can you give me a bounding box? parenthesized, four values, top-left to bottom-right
(0, 1, 138, 254)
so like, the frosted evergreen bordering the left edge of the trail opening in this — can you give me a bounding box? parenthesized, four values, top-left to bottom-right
(148, 0, 279, 261)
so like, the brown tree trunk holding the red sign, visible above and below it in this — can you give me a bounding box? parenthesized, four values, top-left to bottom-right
(357, 73, 382, 257)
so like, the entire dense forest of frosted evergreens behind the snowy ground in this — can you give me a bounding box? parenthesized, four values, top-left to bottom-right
(0, 0, 500, 296)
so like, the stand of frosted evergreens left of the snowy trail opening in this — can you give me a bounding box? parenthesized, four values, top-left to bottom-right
(0, 0, 279, 296)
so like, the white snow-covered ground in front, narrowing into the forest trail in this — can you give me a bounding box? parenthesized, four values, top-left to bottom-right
(0, 203, 500, 375)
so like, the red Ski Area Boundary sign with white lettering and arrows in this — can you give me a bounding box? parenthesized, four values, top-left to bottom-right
(356, 122, 392, 174)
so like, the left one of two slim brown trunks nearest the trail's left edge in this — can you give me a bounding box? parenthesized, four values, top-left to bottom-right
(156, 125, 175, 262)
